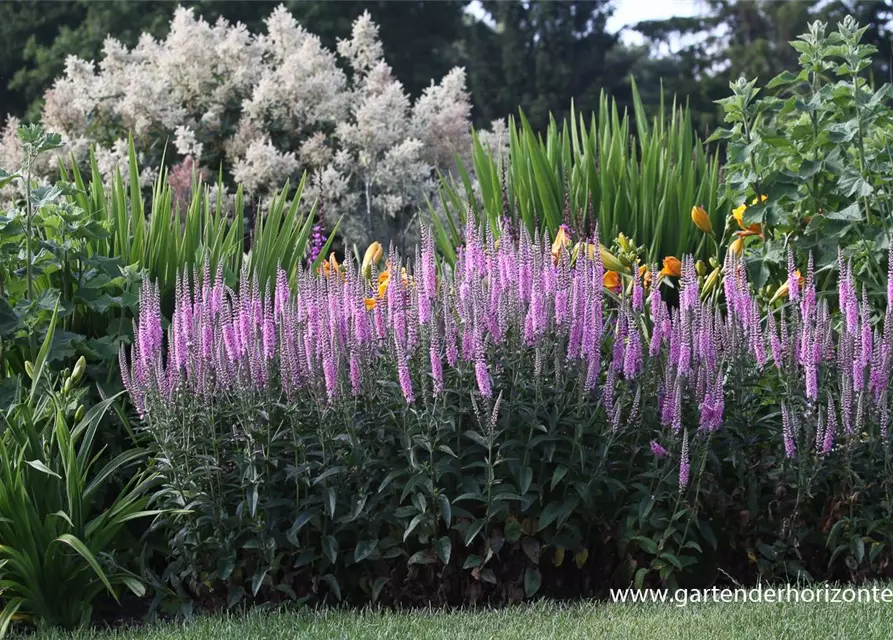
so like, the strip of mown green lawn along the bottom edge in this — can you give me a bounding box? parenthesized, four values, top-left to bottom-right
(32, 602, 893, 640)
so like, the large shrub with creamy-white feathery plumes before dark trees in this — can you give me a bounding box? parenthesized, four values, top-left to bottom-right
(0, 7, 480, 249)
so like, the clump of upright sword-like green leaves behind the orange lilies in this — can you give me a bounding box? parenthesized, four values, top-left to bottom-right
(432, 84, 730, 264)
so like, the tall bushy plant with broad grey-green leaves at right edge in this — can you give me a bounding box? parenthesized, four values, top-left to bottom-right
(713, 18, 893, 292)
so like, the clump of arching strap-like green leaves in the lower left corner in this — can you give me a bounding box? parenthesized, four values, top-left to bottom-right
(0, 314, 158, 637)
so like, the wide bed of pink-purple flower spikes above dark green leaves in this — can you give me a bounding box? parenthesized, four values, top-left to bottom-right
(121, 223, 893, 604)
